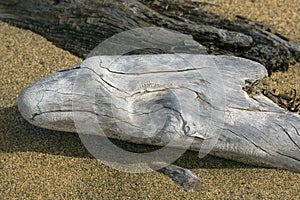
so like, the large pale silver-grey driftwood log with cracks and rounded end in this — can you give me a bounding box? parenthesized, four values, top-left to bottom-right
(18, 54, 300, 172)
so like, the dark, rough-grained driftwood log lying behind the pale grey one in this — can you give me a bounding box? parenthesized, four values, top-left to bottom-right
(0, 0, 300, 72)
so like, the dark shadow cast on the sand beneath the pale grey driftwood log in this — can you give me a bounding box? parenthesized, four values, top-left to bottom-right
(0, 105, 255, 169)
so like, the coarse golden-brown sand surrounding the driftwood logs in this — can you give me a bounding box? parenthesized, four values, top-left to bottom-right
(0, 0, 300, 200)
